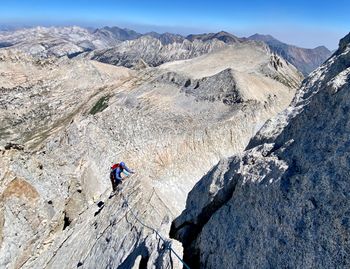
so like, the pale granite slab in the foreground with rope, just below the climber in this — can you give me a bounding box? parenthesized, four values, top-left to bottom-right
(22, 177, 181, 268)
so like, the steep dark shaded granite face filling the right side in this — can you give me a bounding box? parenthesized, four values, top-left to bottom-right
(171, 34, 350, 268)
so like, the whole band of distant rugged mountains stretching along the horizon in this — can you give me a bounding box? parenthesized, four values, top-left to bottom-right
(0, 26, 331, 76)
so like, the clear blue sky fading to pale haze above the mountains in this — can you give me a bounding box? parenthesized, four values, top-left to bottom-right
(0, 0, 350, 49)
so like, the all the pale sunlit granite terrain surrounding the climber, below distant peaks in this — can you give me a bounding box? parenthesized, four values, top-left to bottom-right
(0, 38, 300, 268)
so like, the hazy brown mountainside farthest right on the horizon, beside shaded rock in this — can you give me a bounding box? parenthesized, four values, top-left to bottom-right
(248, 34, 332, 76)
